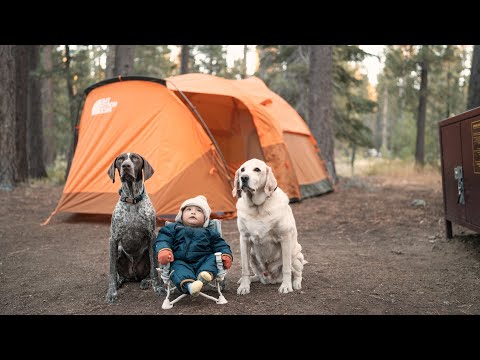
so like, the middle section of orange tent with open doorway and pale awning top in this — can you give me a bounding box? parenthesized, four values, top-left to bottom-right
(167, 74, 300, 199)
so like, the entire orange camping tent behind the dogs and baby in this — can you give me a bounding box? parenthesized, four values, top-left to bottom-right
(44, 74, 334, 224)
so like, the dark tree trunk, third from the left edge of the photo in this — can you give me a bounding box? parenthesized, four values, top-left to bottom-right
(27, 45, 47, 178)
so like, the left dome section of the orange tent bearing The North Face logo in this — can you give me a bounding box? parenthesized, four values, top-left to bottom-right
(45, 77, 236, 224)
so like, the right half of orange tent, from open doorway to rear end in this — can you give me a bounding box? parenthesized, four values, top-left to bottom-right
(166, 74, 333, 200)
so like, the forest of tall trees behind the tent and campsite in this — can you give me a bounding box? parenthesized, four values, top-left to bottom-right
(0, 45, 480, 190)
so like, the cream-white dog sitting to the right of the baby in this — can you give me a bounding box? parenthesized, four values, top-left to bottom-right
(232, 159, 306, 295)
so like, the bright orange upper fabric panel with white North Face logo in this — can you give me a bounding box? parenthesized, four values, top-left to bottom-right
(65, 81, 211, 192)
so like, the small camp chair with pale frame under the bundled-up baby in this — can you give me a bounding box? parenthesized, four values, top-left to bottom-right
(157, 219, 228, 309)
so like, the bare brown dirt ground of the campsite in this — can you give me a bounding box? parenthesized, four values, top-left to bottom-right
(0, 170, 480, 315)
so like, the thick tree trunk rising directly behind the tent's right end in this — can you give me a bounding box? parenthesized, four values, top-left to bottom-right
(308, 45, 337, 182)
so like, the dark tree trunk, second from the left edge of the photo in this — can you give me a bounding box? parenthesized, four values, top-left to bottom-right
(15, 45, 30, 182)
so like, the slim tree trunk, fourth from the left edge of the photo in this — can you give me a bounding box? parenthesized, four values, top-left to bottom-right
(42, 45, 57, 166)
